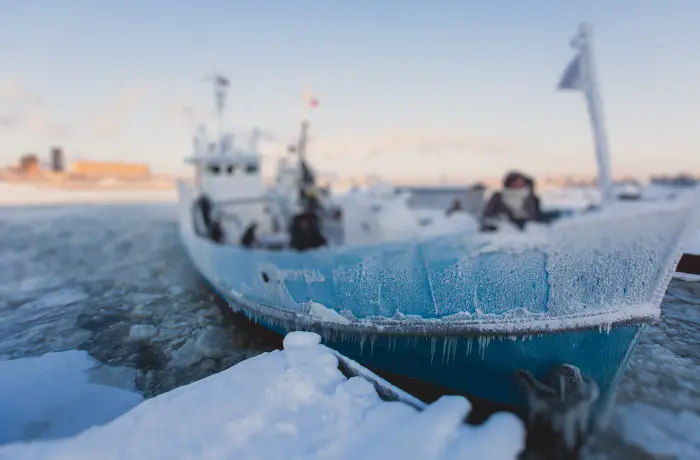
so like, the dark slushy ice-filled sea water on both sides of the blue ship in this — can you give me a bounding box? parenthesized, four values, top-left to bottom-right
(0, 197, 700, 459)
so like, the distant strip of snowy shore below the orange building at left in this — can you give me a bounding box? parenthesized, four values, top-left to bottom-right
(0, 182, 177, 206)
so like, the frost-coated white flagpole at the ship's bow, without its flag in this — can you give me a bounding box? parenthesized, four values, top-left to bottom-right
(579, 23, 614, 206)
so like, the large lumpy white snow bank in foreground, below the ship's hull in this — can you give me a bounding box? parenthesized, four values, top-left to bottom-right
(0, 332, 525, 460)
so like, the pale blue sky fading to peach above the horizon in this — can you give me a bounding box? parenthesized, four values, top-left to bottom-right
(0, 0, 700, 181)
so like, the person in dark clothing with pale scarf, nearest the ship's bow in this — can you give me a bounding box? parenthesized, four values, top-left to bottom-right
(481, 172, 542, 232)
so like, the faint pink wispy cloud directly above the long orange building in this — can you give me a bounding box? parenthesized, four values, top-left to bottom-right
(88, 86, 146, 138)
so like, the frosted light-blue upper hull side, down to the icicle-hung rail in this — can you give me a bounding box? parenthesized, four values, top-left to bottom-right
(183, 198, 691, 336)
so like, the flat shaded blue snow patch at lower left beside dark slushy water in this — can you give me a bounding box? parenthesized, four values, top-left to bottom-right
(0, 350, 143, 444)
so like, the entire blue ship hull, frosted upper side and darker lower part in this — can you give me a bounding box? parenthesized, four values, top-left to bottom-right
(181, 185, 691, 422)
